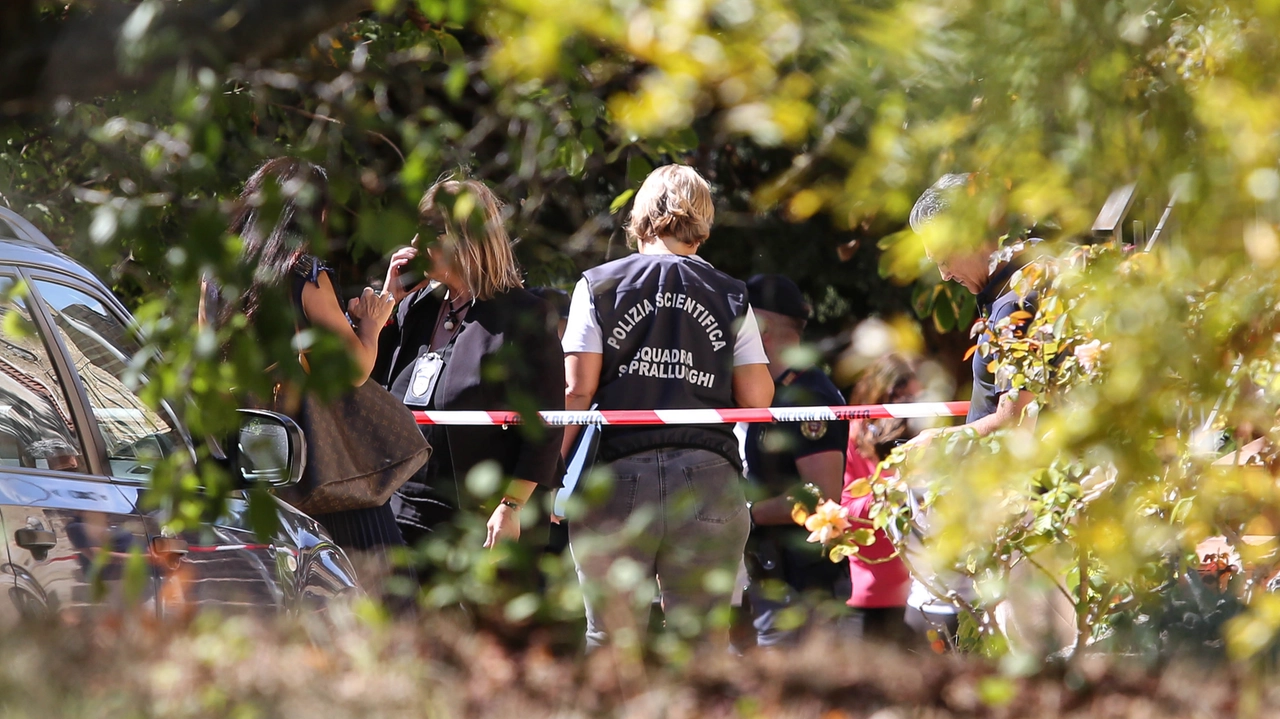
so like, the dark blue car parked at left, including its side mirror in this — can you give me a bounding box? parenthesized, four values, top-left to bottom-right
(0, 207, 360, 624)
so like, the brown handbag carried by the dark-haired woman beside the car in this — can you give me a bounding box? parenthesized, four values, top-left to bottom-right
(274, 381, 431, 514)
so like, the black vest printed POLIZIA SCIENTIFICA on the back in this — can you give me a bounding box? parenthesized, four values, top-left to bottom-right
(584, 255, 746, 466)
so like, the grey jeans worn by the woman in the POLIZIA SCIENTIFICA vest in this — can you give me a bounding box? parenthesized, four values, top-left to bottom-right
(570, 449, 750, 649)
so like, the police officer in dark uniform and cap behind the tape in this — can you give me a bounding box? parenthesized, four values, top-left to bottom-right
(740, 275, 849, 646)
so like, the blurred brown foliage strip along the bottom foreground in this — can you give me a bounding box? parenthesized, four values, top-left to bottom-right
(0, 608, 1259, 719)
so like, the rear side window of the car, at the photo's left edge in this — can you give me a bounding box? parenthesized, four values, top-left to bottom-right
(0, 275, 84, 472)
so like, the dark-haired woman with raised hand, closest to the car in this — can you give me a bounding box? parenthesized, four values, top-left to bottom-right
(212, 157, 403, 551)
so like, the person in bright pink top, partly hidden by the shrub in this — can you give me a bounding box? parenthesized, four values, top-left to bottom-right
(841, 354, 920, 645)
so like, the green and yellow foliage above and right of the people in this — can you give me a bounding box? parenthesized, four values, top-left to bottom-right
(0, 0, 1280, 659)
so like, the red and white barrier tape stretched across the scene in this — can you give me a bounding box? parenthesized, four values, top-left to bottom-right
(413, 402, 969, 427)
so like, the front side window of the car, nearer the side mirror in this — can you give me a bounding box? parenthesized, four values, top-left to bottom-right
(35, 280, 183, 480)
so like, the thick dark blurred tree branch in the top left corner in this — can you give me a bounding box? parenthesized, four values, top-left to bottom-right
(0, 0, 369, 115)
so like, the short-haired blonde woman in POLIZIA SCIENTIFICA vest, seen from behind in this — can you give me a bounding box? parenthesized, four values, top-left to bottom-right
(563, 165, 773, 647)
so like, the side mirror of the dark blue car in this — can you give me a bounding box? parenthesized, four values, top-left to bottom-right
(234, 409, 307, 487)
